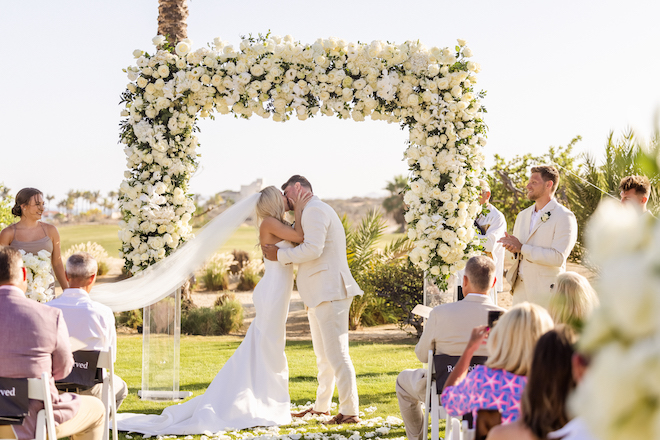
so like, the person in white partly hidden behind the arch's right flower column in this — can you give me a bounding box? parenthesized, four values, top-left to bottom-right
(476, 179, 506, 304)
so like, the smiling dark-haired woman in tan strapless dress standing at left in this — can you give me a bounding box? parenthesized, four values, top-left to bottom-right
(0, 188, 69, 289)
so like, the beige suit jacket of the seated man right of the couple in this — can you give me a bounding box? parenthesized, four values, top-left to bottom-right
(415, 294, 506, 363)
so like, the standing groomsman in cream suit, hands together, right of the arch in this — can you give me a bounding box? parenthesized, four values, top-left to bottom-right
(500, 165, 577, 308)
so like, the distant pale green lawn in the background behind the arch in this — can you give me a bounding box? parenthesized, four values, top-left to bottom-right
(58, 224, 402, 258)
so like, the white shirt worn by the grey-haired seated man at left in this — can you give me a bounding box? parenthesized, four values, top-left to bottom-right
(46, 288, 117, 362)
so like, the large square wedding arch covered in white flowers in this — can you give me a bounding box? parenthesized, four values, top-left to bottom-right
(120, 35, 486, 286)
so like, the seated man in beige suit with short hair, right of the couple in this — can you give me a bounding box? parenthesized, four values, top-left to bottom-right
(396, 255, 505, 440)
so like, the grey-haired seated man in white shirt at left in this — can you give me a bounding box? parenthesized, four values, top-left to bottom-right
(48, 252, 128, 408)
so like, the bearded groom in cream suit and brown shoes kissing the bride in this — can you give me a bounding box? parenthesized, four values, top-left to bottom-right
(262, 175, 363, 424)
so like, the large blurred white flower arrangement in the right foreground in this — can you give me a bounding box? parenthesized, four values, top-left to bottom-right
(571, 200, 660, 440)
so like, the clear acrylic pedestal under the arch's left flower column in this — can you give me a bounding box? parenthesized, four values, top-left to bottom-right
(138, 288, 192, 400)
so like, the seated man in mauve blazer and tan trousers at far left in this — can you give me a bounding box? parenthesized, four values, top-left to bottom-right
(0, 246, 105, 440)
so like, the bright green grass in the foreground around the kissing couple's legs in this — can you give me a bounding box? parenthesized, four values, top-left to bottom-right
(115, 335, 428, 439)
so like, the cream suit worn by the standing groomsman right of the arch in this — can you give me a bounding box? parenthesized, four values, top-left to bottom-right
(506, 198, 577, 308)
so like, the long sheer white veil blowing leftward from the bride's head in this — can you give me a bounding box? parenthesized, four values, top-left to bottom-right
(90, 193, 261, 312)
